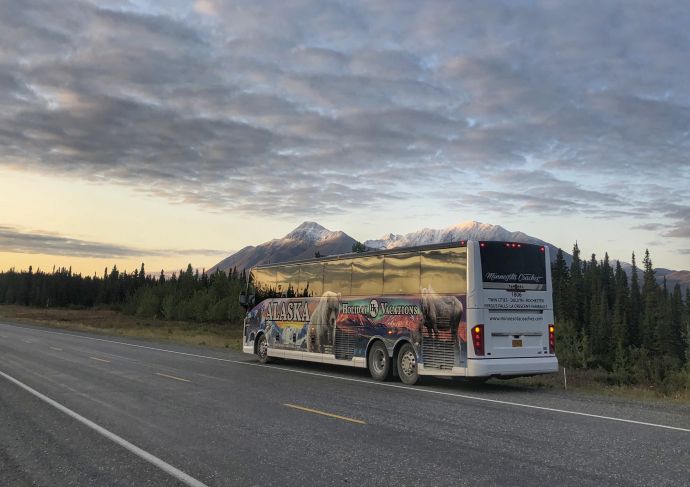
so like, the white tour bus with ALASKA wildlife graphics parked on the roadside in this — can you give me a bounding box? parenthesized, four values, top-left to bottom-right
(240, 241, 558, 384)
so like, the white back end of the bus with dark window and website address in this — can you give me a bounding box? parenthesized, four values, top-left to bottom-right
(468, 242, 553, 359)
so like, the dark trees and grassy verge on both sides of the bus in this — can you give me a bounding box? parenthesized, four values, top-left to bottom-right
(0, 244, 690, 401)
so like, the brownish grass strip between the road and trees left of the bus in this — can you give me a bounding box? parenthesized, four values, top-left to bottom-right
(0, 305, 242, 350)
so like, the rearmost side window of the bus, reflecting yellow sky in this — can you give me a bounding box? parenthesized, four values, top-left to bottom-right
(421, 247, 467, 294)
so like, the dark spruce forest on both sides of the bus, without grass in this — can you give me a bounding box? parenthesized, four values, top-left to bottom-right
(0, 244, 690, 391)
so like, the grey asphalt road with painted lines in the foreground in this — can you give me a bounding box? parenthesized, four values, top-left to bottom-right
(0, 323, 690, 486)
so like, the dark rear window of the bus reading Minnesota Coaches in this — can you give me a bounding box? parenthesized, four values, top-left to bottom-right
(479, 242, 546, 291)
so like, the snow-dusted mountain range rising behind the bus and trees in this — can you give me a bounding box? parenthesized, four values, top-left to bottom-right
(208, 221, 690, 292)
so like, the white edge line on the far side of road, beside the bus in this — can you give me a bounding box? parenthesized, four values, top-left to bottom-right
(5, 323, 690, 433)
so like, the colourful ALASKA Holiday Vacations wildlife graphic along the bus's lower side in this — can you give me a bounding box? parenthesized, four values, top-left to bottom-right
(244, 292, 467, 364)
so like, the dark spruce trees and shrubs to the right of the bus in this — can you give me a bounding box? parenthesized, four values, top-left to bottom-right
(552, 244, 690, 399)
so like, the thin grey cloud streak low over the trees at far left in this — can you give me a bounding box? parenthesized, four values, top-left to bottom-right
(0, 225, 228, 259)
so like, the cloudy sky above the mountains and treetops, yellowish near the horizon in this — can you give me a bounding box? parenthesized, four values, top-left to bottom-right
(0, 0, 690, 273)
